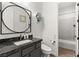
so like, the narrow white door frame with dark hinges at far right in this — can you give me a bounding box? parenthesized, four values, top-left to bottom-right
(58, 2, 79, 56)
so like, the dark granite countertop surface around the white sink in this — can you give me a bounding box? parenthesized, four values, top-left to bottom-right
(0, 38, 42, 54)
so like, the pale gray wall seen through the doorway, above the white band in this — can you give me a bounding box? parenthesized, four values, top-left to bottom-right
(58, 2, 75, 40)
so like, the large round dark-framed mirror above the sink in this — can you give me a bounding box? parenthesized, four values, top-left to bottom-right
(1, 2, 31, 33)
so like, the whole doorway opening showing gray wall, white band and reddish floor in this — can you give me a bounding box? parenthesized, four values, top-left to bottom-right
(58, 2, 77, 57)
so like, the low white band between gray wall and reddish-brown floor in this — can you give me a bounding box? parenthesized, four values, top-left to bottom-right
(59, 39, 76, 50)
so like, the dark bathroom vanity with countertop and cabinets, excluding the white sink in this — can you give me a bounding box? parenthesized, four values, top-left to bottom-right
(0, 38, 42, 57)
